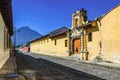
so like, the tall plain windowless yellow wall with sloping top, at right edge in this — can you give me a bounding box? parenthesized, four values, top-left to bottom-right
(101, 5, 120, 62)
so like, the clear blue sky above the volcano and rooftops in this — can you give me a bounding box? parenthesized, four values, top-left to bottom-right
(12, 0, 120, 35)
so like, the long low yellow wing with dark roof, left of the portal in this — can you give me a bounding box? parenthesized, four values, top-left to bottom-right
(30, 27, 68, 57)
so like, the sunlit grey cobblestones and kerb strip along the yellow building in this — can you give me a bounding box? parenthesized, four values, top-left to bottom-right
(23, 52, 120, 80)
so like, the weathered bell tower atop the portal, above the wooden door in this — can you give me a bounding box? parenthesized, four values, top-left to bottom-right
(71, 8, 87, 28)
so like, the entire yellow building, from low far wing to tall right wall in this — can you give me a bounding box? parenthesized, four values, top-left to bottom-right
(31, 5, 120, 63)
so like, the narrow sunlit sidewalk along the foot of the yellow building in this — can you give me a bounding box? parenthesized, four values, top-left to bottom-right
(23, 52, 120, 70)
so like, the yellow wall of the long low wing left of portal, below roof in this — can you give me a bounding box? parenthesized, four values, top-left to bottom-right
(30, 34, 68, 57)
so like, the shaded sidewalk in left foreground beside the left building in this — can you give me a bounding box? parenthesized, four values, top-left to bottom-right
(0, 56, 18, 80)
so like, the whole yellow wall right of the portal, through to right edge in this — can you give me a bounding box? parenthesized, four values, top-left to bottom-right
(87, 6, 120, 63)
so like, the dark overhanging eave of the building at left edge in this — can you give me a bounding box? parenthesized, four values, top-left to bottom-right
(0, 0, 13, 35)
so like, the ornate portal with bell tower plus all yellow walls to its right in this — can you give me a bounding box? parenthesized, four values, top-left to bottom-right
(68, 5, 120, 62)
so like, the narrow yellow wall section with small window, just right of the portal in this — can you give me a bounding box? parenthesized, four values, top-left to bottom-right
(87, 26, 100, 60)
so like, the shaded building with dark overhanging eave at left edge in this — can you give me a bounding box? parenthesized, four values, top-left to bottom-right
(0, 0, 13, 68)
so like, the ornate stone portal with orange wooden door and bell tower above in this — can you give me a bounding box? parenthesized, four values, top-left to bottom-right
(68, 9, 88, 59)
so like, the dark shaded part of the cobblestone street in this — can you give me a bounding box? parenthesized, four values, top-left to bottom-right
(16, 53, 103, 80)
